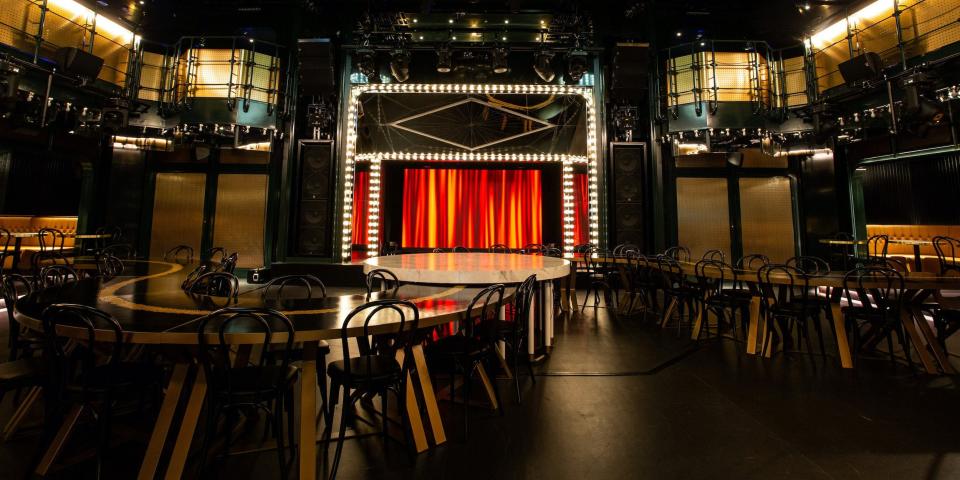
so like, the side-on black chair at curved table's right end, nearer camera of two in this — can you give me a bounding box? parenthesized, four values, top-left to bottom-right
(426, 283, 506, 439)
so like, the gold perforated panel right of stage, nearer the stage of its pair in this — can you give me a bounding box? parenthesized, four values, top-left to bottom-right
(677, 178, 730, 258)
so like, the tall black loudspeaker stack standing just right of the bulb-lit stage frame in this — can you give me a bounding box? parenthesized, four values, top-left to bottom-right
(608, 142, 649, 249)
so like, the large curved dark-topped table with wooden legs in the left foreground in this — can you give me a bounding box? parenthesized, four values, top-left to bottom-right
(15, 261, 488, 479)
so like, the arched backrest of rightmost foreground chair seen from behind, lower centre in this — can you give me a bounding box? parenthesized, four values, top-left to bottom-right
(340, 298, 420, 376)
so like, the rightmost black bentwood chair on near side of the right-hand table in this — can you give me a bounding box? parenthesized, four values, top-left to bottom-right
(841, 267, 913, 368)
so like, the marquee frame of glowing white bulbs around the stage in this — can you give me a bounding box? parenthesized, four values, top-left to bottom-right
(341, 83, 600, 261)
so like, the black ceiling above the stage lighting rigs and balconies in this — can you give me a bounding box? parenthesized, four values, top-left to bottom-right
(87, 0, 856, 47)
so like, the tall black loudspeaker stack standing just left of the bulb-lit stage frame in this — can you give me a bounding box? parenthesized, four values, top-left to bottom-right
(295, 141, 334, 257)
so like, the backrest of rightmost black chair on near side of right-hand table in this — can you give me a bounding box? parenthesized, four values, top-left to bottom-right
(843, 267, 904, 318)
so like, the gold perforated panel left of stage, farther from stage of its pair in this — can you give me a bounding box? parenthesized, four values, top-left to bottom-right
(150, 173, 206, 258)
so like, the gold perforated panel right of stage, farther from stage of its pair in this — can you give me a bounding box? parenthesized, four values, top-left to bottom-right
(740, 177, 795, 263)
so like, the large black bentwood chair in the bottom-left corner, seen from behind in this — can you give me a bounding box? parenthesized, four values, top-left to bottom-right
(36, 304, 163, 478)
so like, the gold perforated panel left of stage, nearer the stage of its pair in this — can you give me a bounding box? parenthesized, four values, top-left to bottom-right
(213, 174, 267, 268)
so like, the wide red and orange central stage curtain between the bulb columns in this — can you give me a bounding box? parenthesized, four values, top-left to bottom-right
(402, 168, 543, 248)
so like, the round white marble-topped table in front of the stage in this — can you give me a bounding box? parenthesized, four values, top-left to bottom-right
(363, 252, 570, 356)
